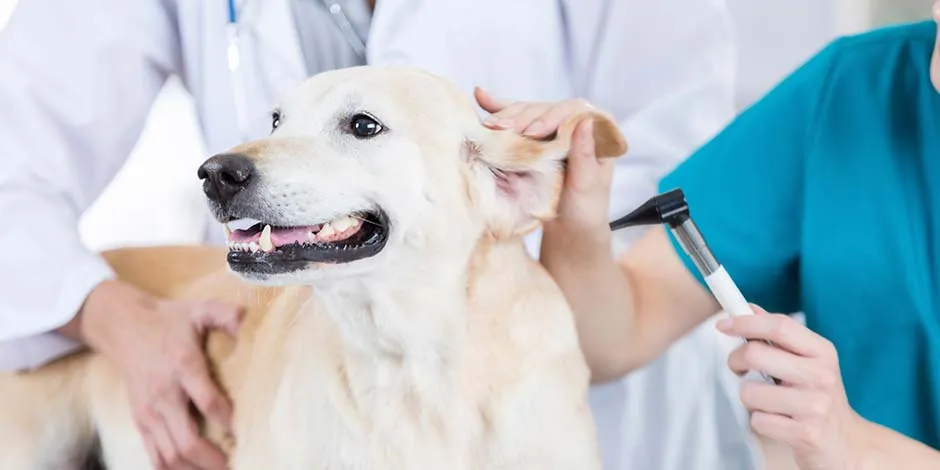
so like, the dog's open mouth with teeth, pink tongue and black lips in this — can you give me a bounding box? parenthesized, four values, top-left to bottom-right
(226, 209, 388, 274)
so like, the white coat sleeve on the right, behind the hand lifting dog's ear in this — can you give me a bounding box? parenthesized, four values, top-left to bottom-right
(563, 0, 737, 251)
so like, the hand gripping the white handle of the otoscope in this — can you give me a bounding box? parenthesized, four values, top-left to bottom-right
(717, 307, 866, 470)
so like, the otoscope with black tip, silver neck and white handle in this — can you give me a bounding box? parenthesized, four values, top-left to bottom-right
(610, 189, 780, 384)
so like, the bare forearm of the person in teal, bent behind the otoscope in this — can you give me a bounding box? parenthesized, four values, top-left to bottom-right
(541, 221, 720, 382)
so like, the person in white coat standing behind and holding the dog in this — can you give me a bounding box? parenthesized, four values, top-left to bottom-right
(0, 0, 755, 470)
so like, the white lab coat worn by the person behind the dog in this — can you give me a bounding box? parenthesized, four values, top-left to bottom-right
(0, 0, 749, 470)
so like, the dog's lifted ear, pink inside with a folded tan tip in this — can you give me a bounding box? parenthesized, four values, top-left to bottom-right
(464, 109, 627, 238)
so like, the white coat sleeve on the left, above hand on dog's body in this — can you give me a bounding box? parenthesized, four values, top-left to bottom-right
(0, 0, 181, 370)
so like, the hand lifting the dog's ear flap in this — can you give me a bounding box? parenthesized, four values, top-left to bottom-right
(474, 88, 614, 252)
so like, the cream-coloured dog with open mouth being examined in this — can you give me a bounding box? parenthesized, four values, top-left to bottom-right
(0, 67, 627, 470)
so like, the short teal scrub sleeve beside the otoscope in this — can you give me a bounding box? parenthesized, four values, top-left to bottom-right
(660, 42, 838, 313)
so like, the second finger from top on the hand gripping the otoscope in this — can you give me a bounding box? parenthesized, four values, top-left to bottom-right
(728, 341, 823, 389)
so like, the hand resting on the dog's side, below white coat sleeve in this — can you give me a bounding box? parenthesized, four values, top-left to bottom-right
(81, 281, 242, 470)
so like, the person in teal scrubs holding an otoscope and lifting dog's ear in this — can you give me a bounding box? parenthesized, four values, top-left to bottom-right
(482, 3, 940, 470)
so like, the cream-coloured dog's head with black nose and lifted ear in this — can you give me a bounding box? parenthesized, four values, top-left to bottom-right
(199, 67, 626, 284)
